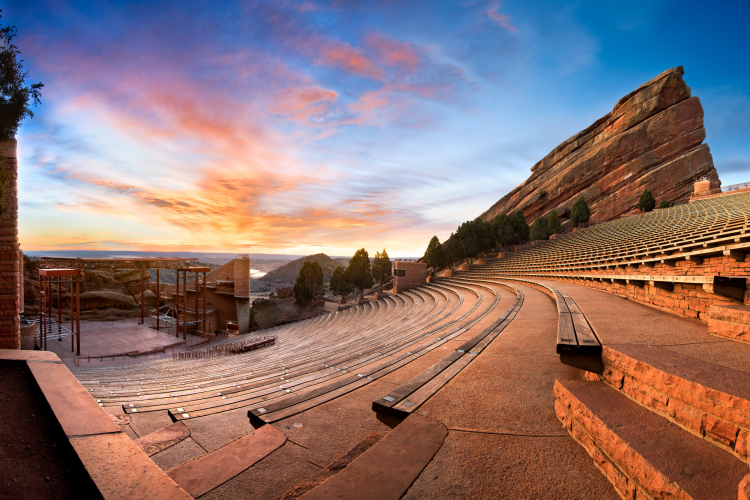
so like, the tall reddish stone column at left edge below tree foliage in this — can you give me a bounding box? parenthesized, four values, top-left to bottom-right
(0, 139, 21, 349)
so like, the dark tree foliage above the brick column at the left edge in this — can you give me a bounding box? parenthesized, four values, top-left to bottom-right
(0, 10, 44, 141)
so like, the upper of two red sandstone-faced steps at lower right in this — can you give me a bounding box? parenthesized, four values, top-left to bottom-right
(601, 344, 750, 461)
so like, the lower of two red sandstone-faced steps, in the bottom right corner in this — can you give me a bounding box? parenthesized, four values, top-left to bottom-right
(555, 380, 750, 500)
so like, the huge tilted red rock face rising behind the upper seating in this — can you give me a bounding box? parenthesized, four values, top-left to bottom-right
(481, 66, 720, 223)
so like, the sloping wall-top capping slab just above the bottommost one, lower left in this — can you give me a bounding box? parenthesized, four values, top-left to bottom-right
(29, 363, 120, 436)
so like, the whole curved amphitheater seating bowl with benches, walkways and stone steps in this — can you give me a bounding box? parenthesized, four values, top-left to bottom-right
(0, 68, 750, 500)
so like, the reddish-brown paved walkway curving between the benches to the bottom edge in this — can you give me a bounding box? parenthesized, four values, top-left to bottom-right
(404, 283, 619, 500)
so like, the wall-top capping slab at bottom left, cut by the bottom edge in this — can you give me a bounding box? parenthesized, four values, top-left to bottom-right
(70, 432, 191, 500)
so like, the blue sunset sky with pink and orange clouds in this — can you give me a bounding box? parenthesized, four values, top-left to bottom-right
(5, 0, 750, 257)
